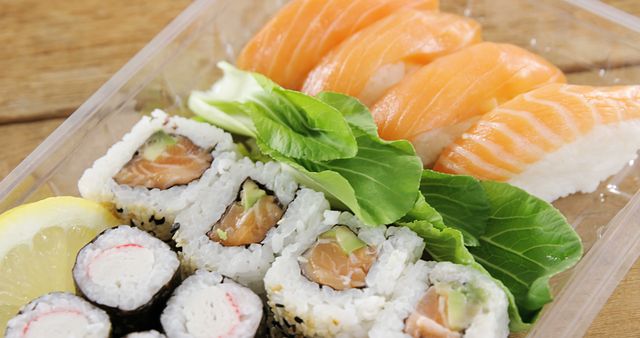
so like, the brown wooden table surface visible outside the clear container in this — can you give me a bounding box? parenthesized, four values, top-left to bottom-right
(0, 0, 640, 337)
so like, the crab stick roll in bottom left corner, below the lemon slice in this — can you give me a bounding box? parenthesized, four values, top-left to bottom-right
(4, 292, 111, 338)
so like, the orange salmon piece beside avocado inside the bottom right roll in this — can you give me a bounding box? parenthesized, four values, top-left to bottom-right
(404, 287, 462, 338)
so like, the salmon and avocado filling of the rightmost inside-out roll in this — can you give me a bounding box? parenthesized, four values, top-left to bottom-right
(404, 286, 479, 338)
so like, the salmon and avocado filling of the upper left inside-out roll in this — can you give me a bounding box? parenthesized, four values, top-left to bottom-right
(113, 131, 213, 190)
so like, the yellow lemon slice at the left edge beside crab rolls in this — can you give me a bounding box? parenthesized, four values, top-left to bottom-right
(0, 197, 120, 333)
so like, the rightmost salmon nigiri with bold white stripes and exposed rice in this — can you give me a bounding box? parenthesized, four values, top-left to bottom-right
(435, 84, 640, 201)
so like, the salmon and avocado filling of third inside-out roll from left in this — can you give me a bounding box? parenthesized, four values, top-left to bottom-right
(301, 226, 377, 290)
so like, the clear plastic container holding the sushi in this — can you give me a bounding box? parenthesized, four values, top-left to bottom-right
(0, 0, 640, 337)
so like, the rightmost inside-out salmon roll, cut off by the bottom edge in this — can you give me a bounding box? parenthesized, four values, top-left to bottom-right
(369, 261, 509, 338)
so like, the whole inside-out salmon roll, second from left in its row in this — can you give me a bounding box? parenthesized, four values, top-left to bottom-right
(174, 159, 329, 293)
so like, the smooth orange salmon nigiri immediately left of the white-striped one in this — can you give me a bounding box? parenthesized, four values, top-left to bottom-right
(372, 42, 566, 166)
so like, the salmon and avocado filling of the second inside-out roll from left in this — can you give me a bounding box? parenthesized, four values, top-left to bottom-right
(207, 180, 284, 246)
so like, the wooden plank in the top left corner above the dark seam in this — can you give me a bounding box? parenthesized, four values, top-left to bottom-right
(0, 0, 189, 123)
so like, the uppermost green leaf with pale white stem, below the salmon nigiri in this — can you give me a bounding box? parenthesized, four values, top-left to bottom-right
(189, 63, 358, 161)
